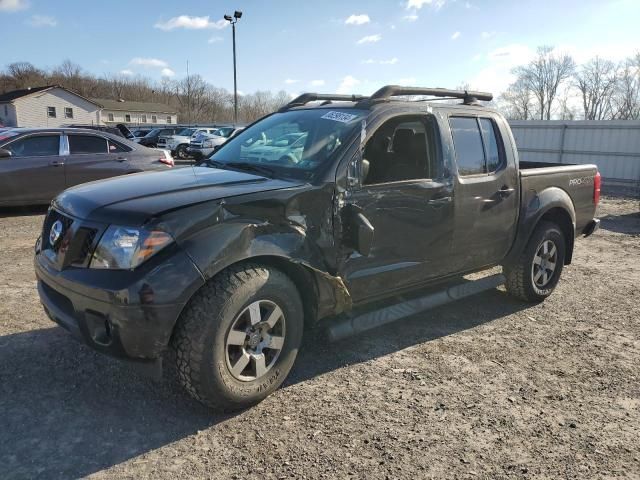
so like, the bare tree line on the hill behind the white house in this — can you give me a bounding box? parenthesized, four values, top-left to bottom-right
(0, 60, 289, 123)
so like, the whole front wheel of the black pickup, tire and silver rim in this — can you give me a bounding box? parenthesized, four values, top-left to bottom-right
(172, 265, 304, 411)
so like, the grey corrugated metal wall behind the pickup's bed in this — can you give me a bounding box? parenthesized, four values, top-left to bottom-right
(509, 120, 640, 187)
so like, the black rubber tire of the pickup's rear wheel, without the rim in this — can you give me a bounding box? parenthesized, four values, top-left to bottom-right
(504, 221, 566, 303)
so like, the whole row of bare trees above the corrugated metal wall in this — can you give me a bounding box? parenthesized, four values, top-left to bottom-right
(497, 46, 640, 120)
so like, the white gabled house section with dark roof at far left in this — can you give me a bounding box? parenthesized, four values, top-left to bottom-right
(0, 85, 101, 127)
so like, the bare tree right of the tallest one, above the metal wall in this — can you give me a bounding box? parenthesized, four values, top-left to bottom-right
(575, 57, 618, 120)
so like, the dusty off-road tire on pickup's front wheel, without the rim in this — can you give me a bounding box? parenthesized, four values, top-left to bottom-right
(171, 264, 304, 411)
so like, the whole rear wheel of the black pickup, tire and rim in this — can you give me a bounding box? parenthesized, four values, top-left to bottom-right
(504, 221, 566, 302)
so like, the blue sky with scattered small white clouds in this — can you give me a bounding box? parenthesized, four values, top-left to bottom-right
(0, 0, 640, 95)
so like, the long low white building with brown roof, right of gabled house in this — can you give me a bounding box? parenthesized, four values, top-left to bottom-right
(91, 98, 178, 125)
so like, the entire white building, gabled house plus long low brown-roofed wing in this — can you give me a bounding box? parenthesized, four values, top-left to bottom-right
(0, 85, 178, 127)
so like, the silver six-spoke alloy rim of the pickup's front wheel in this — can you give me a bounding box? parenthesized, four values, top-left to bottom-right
(225, 300, 285, 382)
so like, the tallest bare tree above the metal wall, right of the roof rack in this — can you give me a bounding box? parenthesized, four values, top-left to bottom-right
(514, 46, 575, 120)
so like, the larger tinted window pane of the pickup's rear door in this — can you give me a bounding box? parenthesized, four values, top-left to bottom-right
(449, 117, 487, 176)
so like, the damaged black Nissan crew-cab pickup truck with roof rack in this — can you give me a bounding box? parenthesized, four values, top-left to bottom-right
(35, 86, 600, 409)
